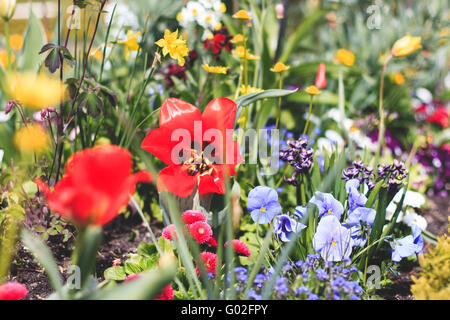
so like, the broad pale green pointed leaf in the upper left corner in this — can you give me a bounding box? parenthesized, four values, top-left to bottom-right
(18, 8, 46, 71)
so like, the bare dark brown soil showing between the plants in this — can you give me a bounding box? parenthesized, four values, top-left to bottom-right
(4, 194, 450, 300)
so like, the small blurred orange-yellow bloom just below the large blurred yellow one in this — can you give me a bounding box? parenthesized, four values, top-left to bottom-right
(14, 124, 50, 154)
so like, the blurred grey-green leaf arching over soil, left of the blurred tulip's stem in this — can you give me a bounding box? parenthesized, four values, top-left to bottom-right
(22, 229, 62, 292)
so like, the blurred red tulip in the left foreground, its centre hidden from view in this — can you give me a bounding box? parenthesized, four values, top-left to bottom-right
(36, 145, 151, 226)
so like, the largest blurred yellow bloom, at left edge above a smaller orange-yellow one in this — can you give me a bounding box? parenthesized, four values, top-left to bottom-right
(7, 73, 64, 110)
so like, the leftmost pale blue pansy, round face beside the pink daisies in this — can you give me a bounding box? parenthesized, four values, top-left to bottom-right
(247, 186, 281, 224)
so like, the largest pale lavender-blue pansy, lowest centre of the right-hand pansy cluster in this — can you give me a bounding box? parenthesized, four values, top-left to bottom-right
(313, 215, 353, 261)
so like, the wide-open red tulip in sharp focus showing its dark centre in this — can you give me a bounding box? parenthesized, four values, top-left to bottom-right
(141, 98, 243, 197)
